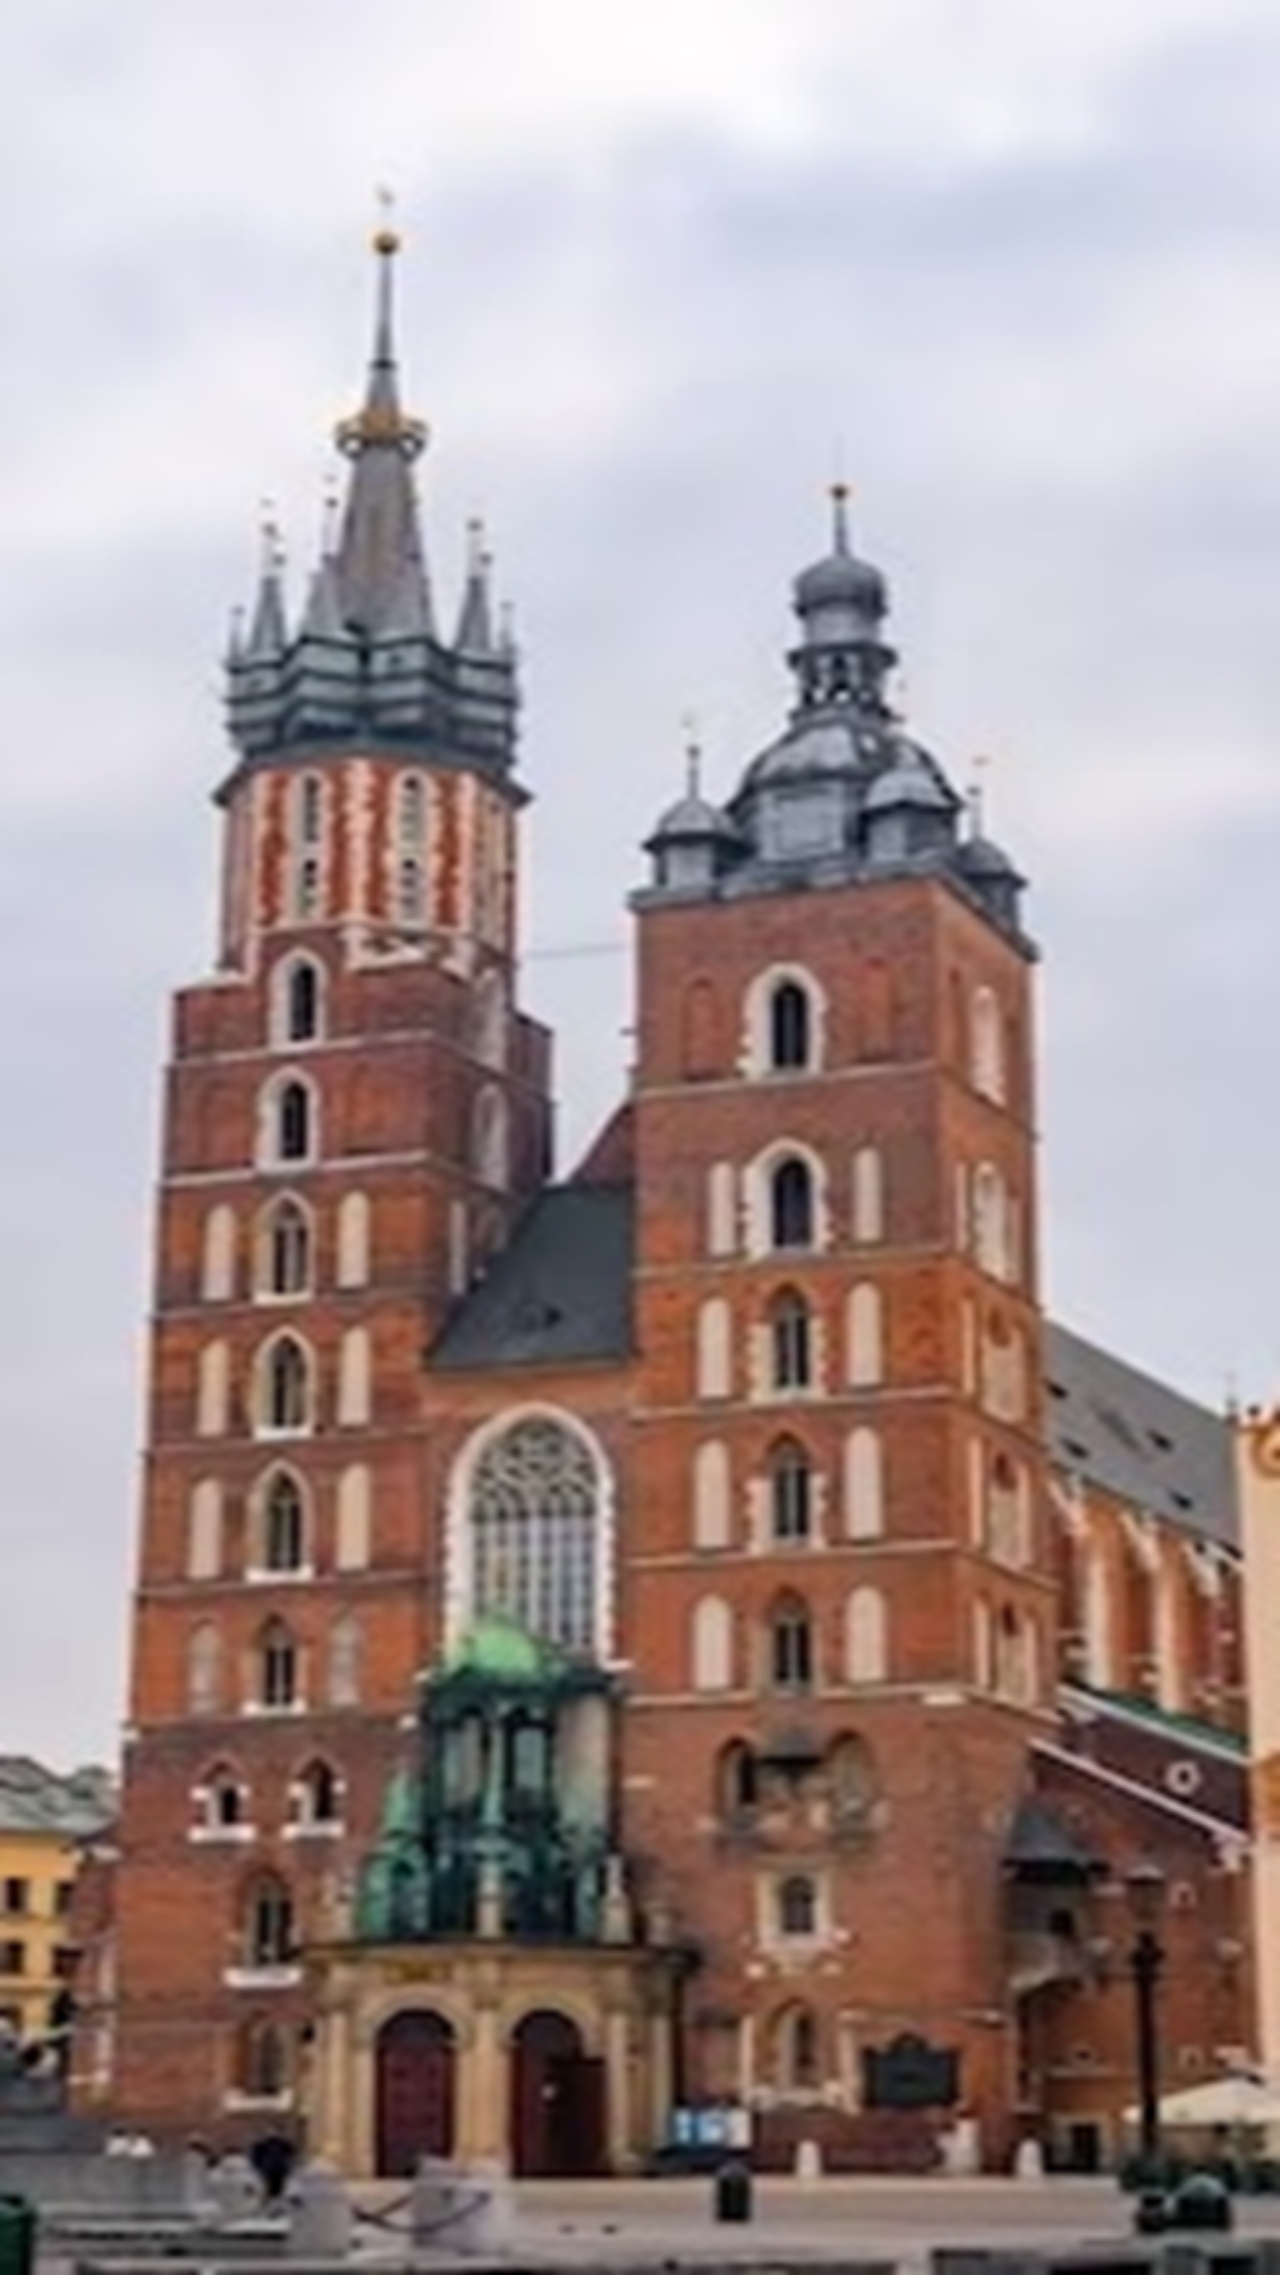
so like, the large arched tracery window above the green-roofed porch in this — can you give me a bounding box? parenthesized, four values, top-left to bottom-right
(468, 1415, 602, 1652)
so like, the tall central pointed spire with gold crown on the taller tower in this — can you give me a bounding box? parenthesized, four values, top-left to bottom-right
(334, 208, 432, 635)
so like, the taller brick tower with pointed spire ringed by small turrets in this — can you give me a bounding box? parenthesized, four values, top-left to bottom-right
(116, 232, 550, 2134)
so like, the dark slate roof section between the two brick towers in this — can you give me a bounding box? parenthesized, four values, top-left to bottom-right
(430, 1185, 632, 1370)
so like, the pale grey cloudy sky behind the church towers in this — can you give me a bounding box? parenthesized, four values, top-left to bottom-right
(0, 0, 1280, 1763)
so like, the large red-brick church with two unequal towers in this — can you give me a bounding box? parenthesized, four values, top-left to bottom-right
(97, 232, 1250, 2173)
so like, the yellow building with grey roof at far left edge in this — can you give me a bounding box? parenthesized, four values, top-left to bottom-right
(0, 1754, 116, 2038)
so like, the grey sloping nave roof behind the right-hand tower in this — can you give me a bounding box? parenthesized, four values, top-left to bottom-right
(1044, 1322, 1237, 1547)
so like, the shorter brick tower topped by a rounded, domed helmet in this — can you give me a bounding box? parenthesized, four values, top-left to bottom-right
(623, 494, 1055, 2152)
